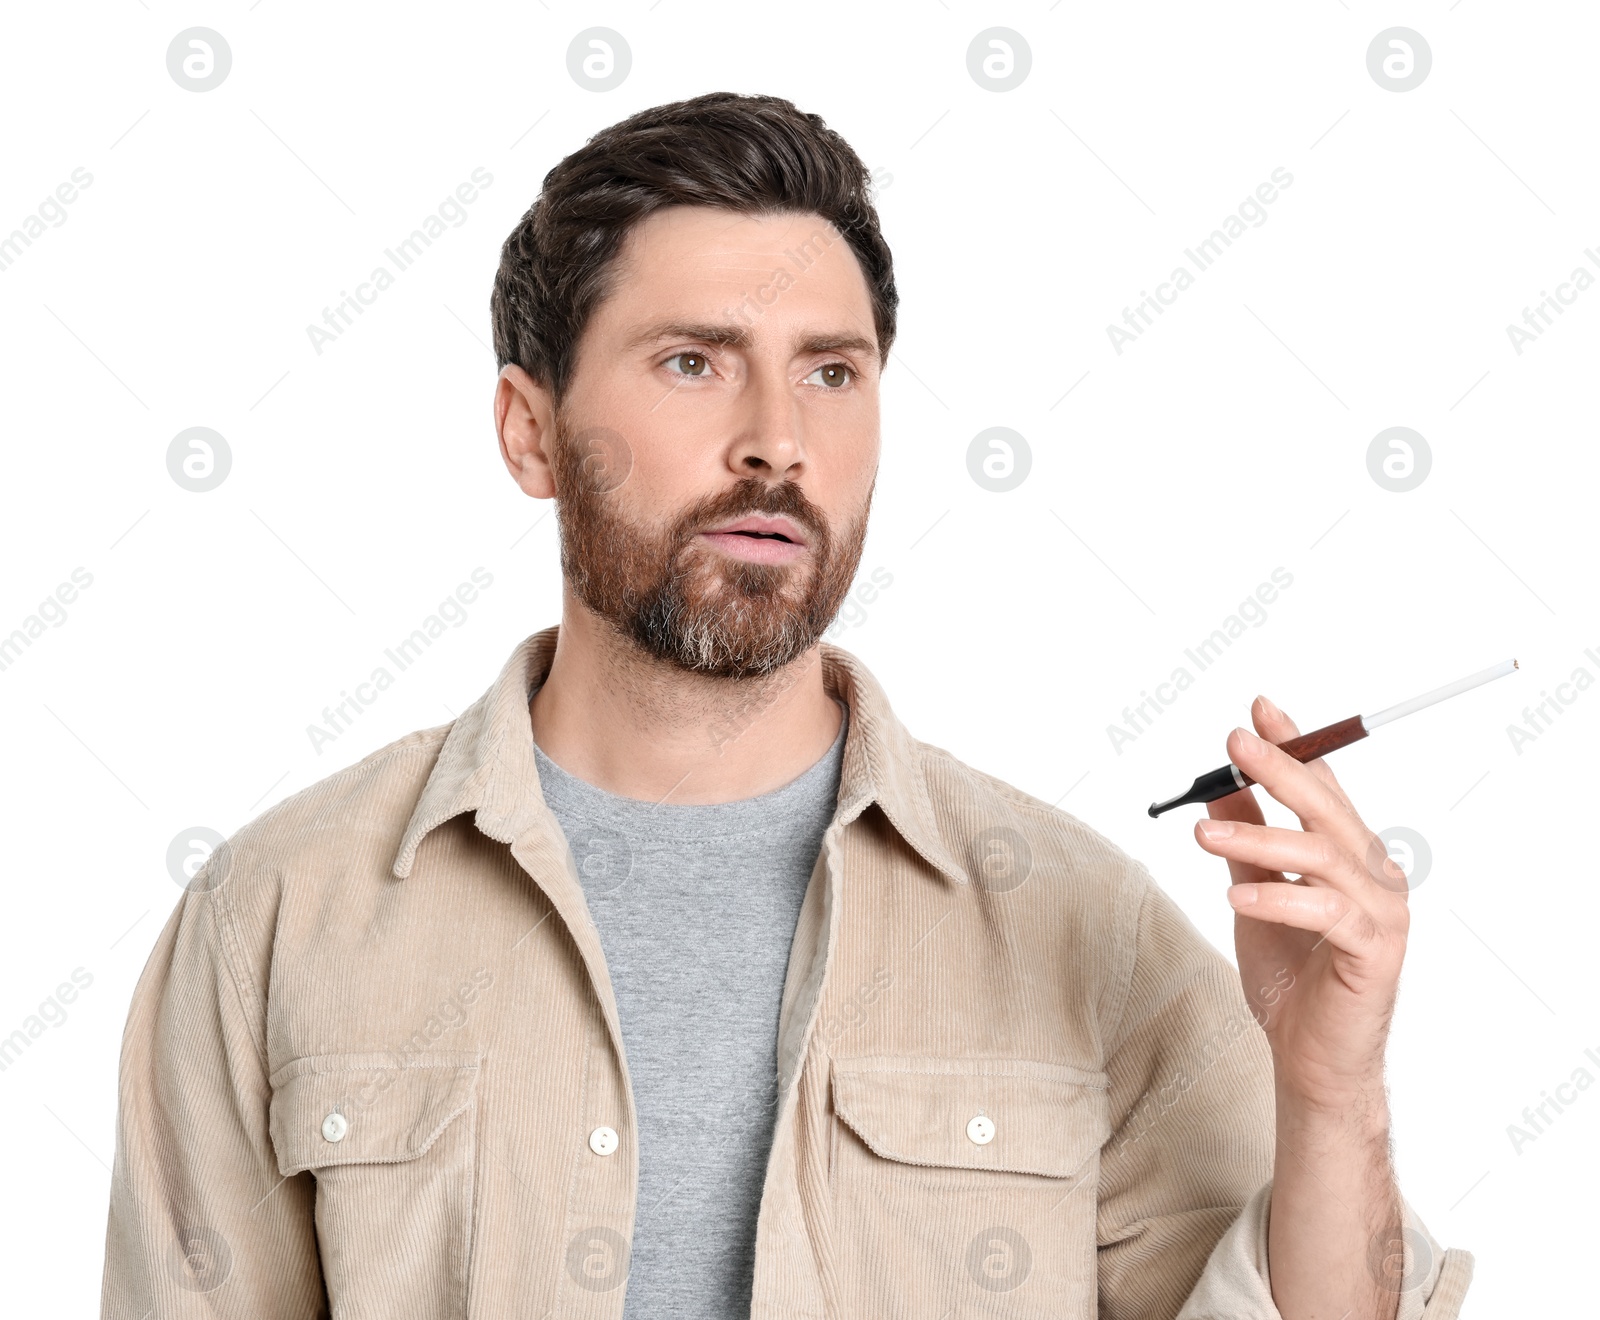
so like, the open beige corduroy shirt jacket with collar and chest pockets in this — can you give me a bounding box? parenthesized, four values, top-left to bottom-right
(102, 627, 1472, 1320)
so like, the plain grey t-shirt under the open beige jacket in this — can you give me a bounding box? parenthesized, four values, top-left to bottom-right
(534, 702, 848, 1320)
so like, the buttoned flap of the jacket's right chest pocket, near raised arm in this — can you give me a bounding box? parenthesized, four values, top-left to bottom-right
(834, 1056, 1110, 1178)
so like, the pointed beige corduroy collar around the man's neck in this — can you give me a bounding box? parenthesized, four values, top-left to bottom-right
(394, 624, 966, 883)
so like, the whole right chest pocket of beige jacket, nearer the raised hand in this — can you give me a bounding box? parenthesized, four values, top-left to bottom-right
(829, 1056, 1110, 1320)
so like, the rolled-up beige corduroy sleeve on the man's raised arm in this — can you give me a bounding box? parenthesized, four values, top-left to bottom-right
(1098, 864, 1472, 1320)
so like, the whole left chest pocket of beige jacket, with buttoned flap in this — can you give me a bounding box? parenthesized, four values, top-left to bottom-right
(270, 1051, 478, 1320)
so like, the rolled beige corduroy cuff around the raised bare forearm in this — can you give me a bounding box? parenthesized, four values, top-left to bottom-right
(1176, 1182, 1472, 1320)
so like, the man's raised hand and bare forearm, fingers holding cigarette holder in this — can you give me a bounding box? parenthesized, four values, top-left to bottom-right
(1195, 696, 1410, 1320)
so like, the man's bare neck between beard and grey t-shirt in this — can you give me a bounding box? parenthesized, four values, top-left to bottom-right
(530, 590, 840, 805)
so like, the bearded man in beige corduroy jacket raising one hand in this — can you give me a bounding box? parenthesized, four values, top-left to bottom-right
(102, 94, 1470, 1320)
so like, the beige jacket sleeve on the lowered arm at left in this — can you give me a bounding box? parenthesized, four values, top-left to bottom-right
(101, 870, 326, 1320)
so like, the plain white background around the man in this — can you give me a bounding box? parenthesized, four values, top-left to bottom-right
(0, 0, 1600, 1317)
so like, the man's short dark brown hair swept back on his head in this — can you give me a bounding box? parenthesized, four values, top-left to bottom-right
(490, 91, 899, 403)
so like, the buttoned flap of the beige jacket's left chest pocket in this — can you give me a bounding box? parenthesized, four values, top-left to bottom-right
(270, 1051, 478, 1176)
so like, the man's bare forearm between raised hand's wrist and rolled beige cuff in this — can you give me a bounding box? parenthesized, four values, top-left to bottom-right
(1267, 1083, 1402, 1320)
